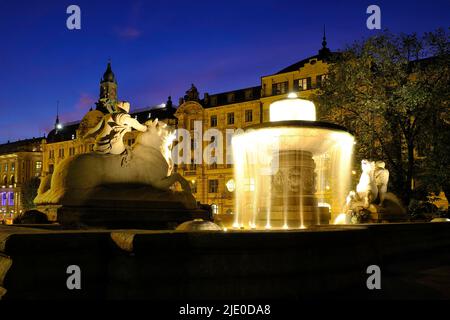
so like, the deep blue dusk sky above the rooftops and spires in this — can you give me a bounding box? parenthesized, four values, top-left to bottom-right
(0, 0, 450, 143)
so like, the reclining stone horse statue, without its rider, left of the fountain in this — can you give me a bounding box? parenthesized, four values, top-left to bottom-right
(34, 119, 191, 206)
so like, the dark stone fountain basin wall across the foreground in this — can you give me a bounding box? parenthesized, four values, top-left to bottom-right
(0, 223, 450, 301)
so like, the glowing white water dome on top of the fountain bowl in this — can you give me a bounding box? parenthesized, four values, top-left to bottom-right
(270, 93, 316, 122)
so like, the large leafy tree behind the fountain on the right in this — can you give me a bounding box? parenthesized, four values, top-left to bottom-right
(315, 29, 450, 204)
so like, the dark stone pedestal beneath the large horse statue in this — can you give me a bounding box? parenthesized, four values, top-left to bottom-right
(38, 184, 213, 230)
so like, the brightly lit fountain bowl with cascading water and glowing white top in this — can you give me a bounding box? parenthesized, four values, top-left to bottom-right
(232, 94, 354, 229)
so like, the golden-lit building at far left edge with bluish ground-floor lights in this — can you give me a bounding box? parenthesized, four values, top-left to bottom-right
(0, 138, 43, 220)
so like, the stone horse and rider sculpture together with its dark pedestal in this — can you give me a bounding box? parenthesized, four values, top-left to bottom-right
(34, 103, 211, 228)
